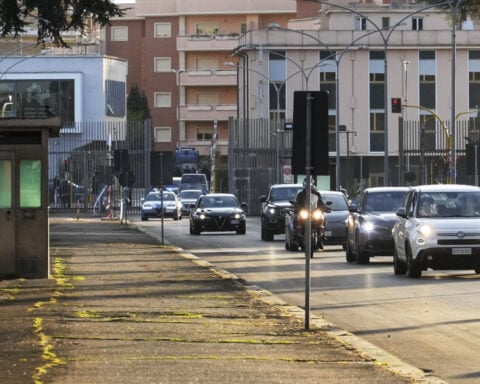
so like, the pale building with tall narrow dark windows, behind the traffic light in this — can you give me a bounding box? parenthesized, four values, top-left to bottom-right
(235, 1, 480, 187)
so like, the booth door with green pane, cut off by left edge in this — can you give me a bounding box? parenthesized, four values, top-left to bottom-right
(0, 151, 16, 275)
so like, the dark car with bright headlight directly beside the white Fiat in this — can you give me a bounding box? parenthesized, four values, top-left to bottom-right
(346, 187, 409, 264)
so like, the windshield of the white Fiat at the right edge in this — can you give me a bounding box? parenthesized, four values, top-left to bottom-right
(417, 191, 480, 217)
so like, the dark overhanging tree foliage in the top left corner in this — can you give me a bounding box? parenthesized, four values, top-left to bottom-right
(0, 0, 126, 46)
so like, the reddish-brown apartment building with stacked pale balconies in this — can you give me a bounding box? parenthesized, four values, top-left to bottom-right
(105, 0, 308, 169)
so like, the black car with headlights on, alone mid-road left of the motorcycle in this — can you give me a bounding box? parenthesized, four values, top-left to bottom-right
(190, 193, 247, 235)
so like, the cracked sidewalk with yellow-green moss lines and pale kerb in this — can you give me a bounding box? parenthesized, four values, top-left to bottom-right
(0, 217, 442, 384)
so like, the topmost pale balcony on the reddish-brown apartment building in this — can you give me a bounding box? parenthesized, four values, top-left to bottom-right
(177, 33, 240, 51)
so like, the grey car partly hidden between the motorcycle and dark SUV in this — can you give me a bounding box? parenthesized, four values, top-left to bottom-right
(320, 191, 350, 249)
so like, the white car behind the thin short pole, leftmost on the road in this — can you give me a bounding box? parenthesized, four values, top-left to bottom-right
(141, 190, 182, 221)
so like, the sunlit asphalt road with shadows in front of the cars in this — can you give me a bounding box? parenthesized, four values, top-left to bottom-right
(131, 217, 480, 384)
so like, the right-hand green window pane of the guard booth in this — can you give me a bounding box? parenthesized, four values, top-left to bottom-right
(20, 160, 42, 208)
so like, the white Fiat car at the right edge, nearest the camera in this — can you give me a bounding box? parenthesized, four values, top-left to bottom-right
(392, 184, 480, 277)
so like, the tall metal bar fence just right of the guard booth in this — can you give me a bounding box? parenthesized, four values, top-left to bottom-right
(49, 121, 151, 215)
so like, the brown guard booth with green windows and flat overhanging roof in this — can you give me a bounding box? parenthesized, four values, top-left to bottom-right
(0, 118, 60, 278)
